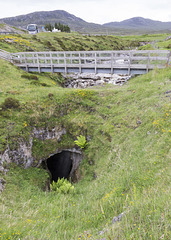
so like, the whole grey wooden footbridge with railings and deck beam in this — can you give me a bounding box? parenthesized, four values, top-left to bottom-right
(0, 50, 171, 75)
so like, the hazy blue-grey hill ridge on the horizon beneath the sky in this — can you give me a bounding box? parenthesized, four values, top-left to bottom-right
(0, 10, 171, 33)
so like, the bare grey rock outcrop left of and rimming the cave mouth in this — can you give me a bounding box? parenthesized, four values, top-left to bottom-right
(0, 127, 82, 181)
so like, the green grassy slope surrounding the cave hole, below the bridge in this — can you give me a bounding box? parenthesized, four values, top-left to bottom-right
(0, 32, 171, 240)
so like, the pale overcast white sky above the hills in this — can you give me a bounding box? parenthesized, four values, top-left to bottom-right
(0, 0, 171, 24)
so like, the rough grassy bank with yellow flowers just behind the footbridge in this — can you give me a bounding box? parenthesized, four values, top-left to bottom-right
(0, 33, 171, 52)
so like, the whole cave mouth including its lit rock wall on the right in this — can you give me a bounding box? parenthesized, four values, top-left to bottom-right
(46, 149, 82, 182)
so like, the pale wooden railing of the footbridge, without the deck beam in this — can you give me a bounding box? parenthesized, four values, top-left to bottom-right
(11, 50, 171, 68)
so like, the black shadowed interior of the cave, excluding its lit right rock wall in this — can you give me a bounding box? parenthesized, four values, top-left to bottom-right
(47, 151, 72, 182)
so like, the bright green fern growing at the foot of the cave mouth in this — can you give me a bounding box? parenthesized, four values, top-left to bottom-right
(50, 178, 74, 194)
